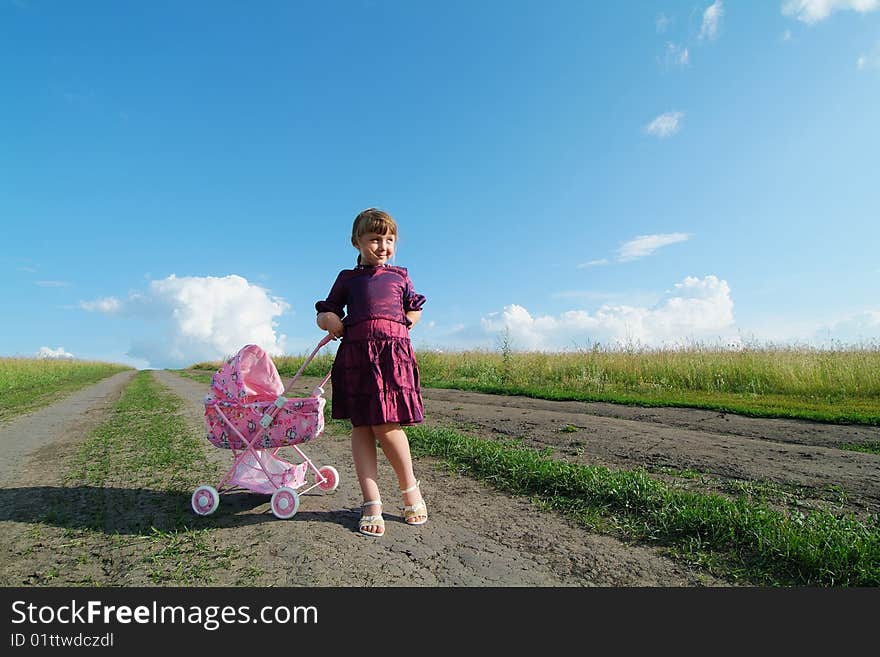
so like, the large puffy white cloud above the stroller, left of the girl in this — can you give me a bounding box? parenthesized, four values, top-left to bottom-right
(80, 274, 290, 367)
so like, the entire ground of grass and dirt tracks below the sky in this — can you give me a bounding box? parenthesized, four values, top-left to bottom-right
(0, 347, 880, 586)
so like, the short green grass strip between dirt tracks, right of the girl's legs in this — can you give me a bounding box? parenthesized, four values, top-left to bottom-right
(407, 426, 880, 586)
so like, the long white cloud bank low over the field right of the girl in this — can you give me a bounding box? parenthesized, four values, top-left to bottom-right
(480, 276, 739, 351)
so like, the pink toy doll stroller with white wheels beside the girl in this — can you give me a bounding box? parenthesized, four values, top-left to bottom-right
(192, 335, 339, 519)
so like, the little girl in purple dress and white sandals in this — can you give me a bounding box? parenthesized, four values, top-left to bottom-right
(315, 208, 428, 536)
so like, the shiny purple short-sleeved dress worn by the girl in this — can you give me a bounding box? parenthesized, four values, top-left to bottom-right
(315, 265, 425, 427)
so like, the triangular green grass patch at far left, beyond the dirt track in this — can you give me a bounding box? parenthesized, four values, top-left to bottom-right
(0, 358, 132, 421)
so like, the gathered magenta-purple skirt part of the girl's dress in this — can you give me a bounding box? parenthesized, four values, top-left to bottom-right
(330, 319, 425, 427)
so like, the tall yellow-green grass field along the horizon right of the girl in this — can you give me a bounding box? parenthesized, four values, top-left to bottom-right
(417, 344, 880, 425)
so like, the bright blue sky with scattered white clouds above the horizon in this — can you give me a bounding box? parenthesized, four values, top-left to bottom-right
(0, 0, 880, 367)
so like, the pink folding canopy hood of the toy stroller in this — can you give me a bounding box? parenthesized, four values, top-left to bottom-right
(211, 344, 284, 404)
